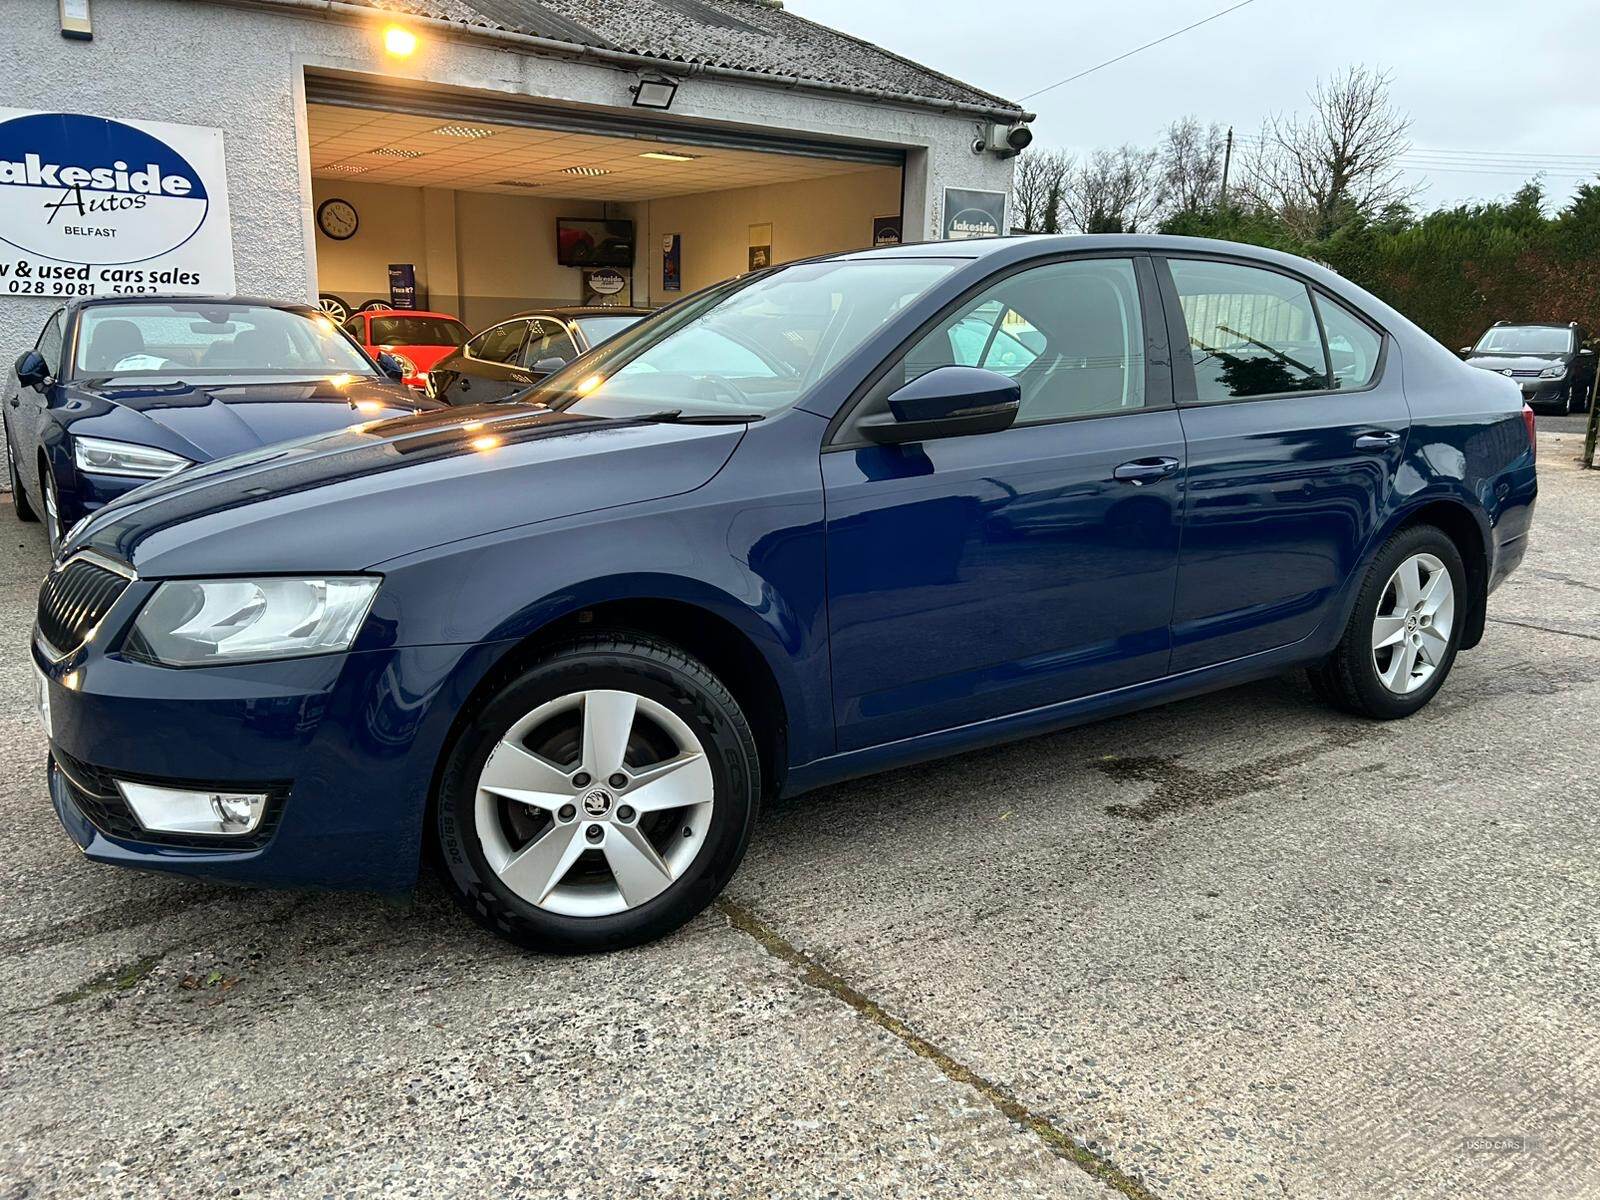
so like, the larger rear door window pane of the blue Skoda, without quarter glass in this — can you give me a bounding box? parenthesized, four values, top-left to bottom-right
(1168, 259, 1330, 405)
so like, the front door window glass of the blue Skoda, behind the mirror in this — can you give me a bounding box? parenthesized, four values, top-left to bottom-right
(878, 259, 1144, 424)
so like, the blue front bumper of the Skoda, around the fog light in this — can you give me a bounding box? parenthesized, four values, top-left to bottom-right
(34, 643, 501, 893)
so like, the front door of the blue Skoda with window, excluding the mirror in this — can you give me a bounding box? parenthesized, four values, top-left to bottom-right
(822, 258, 1184, 750)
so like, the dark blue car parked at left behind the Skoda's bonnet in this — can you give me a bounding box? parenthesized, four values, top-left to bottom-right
(3, 296, 440, 549)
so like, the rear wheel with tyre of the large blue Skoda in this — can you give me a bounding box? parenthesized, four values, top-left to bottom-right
(1310, 525, 1467, 720)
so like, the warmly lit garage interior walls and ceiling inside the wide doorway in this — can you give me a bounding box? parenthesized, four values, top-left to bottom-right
(306, 86, 902, 331)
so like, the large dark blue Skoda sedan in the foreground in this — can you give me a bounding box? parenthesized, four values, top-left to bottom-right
(34, 237, 1538, 950)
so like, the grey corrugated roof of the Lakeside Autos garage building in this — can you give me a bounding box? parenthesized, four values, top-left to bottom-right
(326, 0, 1021, 112)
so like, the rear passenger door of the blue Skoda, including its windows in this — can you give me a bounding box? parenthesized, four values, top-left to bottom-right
(1158, 256, 1410, 674)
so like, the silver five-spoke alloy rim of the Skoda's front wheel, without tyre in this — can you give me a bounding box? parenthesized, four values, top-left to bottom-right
(474, 690, 715, 917)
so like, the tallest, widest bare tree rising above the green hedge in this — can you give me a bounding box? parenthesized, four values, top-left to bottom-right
(1242, 67, 1414, 238)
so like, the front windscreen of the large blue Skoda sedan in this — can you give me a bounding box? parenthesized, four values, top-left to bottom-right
(534, 258, 960, 416)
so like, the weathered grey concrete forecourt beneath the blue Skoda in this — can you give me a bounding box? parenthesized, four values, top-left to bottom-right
(0, 435, 1600, 1200)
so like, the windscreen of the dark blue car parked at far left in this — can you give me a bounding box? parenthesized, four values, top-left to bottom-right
(75, 301, 373, 376)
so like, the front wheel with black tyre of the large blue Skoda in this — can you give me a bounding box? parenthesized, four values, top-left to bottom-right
(435, 634, 762, 954)
